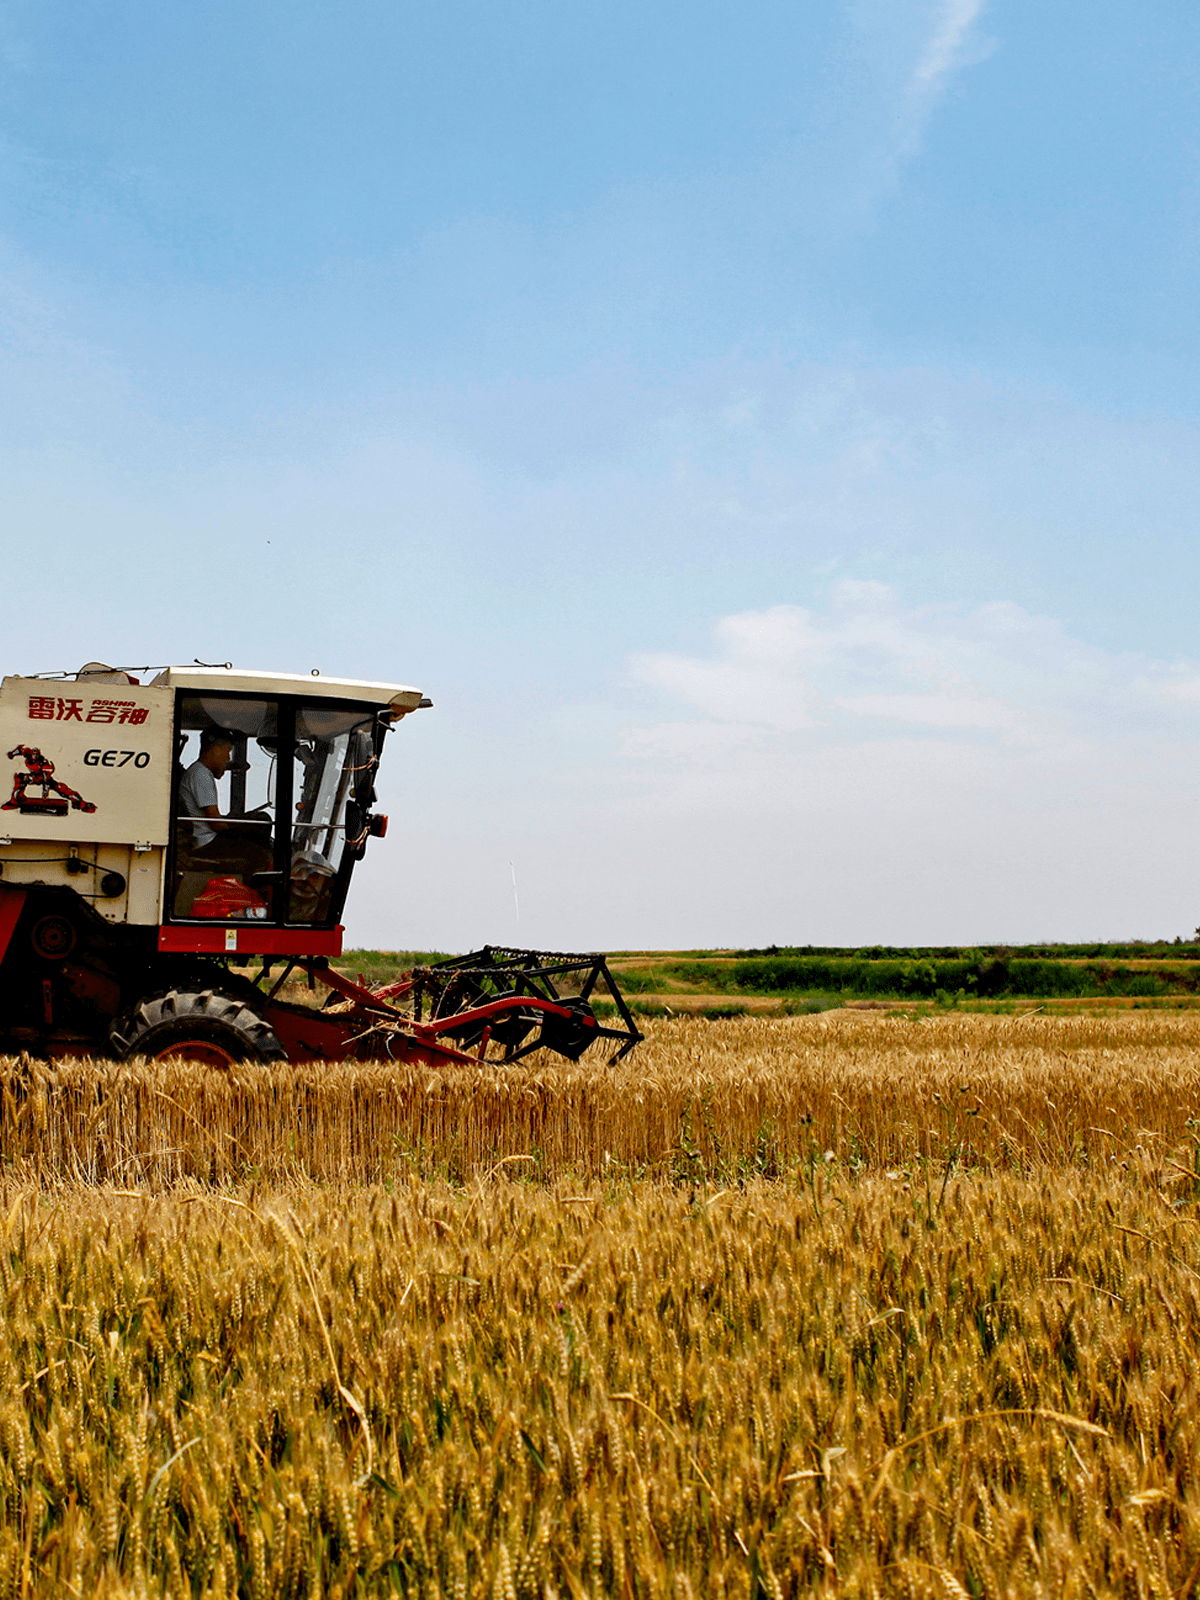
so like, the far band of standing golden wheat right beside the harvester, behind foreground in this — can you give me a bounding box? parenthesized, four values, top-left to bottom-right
(0, 1013, 1200, 1186)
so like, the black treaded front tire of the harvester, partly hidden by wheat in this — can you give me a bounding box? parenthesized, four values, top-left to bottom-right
(109, 989, 288, 1066)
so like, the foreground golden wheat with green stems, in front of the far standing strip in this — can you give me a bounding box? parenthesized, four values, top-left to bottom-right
(0, 1173, 1200, 1600)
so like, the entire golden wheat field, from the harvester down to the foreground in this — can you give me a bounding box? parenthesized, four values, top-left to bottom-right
(0, 1013, 1200, 1600)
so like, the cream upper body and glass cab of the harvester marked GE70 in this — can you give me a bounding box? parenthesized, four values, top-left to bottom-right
(0, 664, 429, 955)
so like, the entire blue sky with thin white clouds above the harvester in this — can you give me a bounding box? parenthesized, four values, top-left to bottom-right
(0, 0, 1200, 949)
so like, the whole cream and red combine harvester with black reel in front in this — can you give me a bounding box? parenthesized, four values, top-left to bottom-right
(0, 662, 642, 1066)
